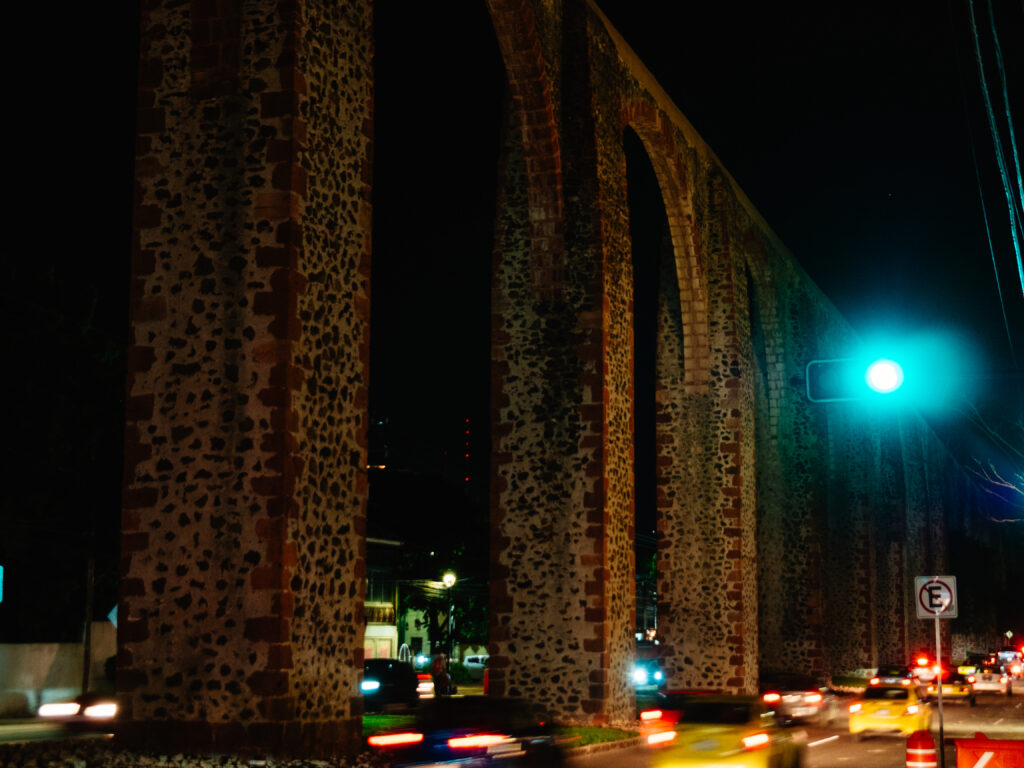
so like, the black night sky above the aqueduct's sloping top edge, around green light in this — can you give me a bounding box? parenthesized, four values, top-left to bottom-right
(598, 0, 1024, 371)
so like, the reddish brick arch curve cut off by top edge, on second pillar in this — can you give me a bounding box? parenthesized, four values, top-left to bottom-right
(487, 0, 565, 299)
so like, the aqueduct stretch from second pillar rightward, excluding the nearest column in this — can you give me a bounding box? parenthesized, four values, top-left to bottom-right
(489, 0, 962, 722)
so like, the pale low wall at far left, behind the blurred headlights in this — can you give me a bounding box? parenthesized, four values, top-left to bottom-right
(0, 622, 118, 718)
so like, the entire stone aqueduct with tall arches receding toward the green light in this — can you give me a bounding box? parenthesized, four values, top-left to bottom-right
(118, 0, 970, 755)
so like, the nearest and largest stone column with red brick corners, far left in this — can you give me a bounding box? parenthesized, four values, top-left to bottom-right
(118, 0, 372, 756)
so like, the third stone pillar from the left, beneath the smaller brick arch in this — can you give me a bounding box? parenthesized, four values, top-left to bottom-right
(657, 177, 758, 692)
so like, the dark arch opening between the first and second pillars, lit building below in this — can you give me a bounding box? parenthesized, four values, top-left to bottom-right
(365, 2, 505, 677)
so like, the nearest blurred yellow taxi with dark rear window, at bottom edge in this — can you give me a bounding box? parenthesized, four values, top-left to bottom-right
(640, 691, 805, 768)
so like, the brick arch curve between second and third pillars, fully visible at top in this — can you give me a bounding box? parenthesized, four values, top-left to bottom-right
(623, 100, 711, 391)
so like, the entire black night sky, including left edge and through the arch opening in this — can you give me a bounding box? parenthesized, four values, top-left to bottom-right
(0, 0, 1024, 641)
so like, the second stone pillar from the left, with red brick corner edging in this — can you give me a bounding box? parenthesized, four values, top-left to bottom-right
(489, 0, 635, 725)
